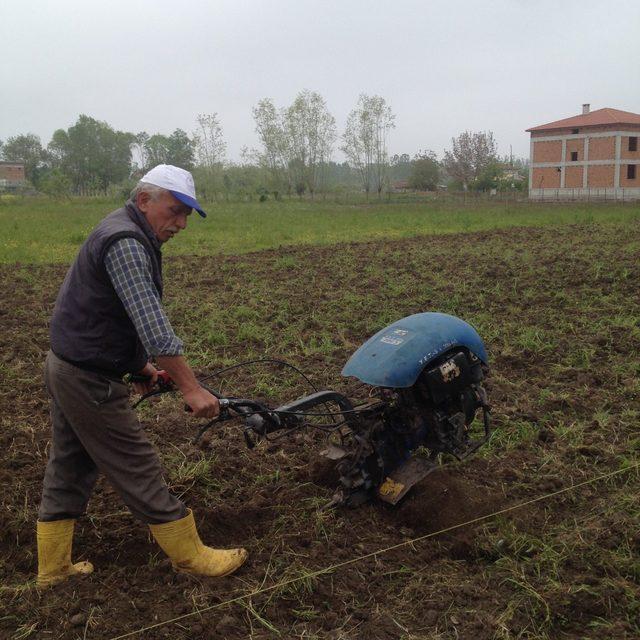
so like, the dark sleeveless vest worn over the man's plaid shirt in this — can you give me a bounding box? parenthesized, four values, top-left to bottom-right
(50, 201, 162, 376)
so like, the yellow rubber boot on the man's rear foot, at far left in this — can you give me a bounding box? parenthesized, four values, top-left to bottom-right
(36, 520, 93, 587)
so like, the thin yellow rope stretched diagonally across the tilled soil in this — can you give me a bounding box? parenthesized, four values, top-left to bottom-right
(110, 462, 640, 640)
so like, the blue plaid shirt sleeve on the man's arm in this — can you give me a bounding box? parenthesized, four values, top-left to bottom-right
(104, 238, 183, 356)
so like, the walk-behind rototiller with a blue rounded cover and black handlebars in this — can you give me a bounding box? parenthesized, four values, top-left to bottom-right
(140, 313, 490, 506)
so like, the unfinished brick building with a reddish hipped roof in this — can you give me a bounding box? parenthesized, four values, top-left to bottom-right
(527, 104, 640, 200)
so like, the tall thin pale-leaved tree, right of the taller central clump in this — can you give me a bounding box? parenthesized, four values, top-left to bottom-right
(341, 93, 395, 197)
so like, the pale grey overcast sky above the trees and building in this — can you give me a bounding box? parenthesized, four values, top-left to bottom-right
(0, 0, 640, 159)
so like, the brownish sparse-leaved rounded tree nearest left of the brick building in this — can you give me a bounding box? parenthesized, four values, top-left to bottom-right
(442, 131, 497, 191)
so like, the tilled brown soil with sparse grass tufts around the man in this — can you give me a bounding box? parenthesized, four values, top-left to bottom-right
(0, 225, 640, 640)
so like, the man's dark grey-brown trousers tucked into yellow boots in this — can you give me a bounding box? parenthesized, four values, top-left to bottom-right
(38, 352, 187, 524)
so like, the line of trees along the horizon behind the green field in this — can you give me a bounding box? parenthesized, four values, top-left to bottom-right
(0, 90, 525, 198)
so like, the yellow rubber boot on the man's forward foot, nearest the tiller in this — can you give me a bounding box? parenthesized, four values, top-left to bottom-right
(149, 509, 248, 577)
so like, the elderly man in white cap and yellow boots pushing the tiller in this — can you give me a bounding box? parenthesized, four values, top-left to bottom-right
(37, 165, 247, 586)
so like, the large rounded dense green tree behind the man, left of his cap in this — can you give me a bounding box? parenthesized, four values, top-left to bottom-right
(48, 115, 135, 192)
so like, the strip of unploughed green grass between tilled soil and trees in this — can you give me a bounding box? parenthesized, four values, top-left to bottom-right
(0, 198, 640, 264)
